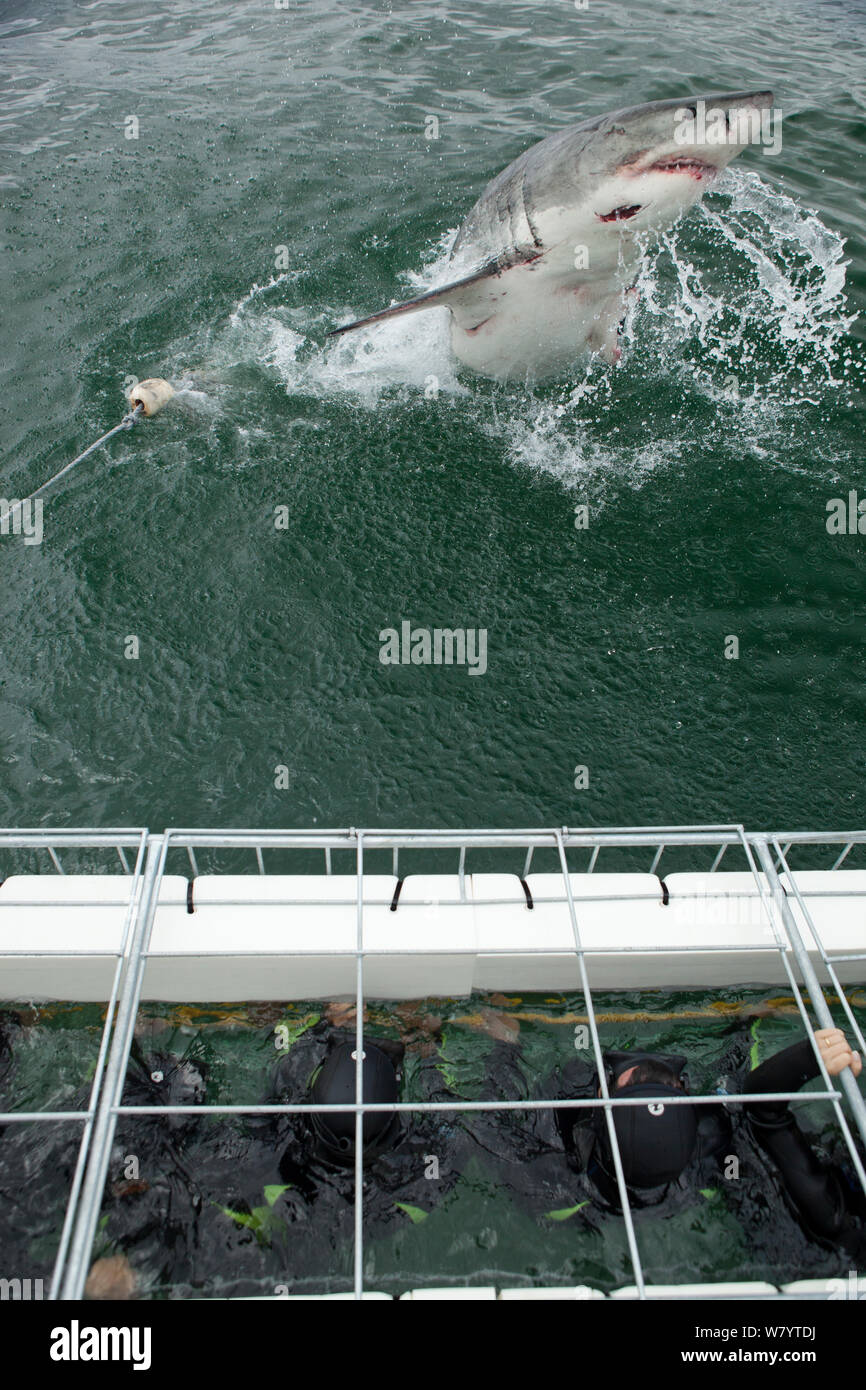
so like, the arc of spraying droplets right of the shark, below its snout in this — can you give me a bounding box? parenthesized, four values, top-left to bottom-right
(626, 170, 856, 409)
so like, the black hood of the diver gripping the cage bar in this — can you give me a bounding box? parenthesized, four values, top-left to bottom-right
(592, 1052, 698, 1194)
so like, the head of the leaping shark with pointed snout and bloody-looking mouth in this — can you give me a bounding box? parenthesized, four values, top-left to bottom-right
(531, 92, 773, 240)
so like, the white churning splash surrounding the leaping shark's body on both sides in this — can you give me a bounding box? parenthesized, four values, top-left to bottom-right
(222, 170, 859, 487)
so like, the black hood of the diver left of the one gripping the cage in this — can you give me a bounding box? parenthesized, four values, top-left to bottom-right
(310, 1043, 402, 1165)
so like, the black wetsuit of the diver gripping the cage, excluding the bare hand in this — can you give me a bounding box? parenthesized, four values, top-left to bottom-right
(471, 1038, 866, 1259)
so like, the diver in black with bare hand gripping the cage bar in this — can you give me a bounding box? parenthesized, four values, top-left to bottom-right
(473, 1029, 866, 1255)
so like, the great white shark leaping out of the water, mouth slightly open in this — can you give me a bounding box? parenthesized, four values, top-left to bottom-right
(332, 90, 773, 381)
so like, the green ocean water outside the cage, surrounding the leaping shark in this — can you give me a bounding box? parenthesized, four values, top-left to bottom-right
(0, 0, 866, 830)
